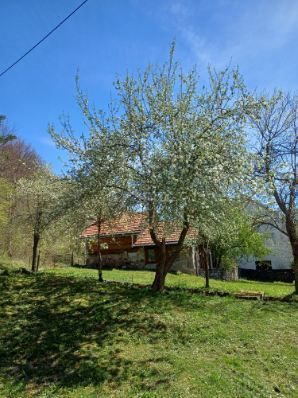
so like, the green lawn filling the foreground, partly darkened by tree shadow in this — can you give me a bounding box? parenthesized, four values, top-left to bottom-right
(0, 269, 298, 398)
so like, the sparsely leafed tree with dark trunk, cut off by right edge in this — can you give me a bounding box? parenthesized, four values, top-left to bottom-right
(252, 91, 298, 293)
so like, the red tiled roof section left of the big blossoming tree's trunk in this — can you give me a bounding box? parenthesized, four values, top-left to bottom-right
(81, 213, 146, 238)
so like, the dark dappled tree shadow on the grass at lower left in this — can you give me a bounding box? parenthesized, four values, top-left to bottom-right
(0, 274, 186, 389)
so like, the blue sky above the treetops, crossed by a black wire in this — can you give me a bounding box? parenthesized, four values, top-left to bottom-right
(0, 0, 298, 171)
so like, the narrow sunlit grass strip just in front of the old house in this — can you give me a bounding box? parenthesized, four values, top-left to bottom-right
(49, 267, 294, 297)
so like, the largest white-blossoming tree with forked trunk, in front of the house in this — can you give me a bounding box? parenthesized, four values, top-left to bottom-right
(50, 48, 252, 291)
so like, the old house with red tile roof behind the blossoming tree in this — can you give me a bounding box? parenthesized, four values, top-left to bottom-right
(81, 213, 199, 274)
